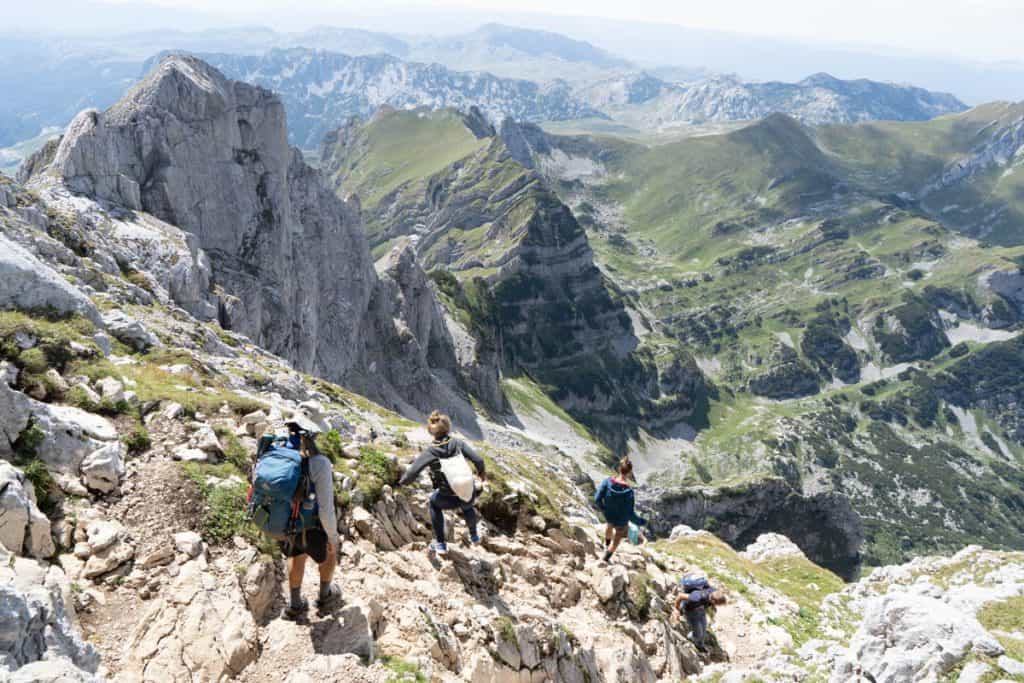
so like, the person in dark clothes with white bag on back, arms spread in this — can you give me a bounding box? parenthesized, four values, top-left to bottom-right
(398, 411, 487, 555)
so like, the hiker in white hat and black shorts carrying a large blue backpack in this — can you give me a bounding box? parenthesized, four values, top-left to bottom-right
(249, 413, 341, 620)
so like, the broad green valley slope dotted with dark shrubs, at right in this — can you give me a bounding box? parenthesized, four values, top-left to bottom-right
(536, 105, 1024, 563)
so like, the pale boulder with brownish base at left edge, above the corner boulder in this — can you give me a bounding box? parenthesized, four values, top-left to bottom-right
(0, 460, 56, 558)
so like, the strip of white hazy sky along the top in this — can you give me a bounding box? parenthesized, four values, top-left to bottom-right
(79, 0, 1024, 61)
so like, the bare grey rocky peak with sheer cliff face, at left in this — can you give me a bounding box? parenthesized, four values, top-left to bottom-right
(18, 56, 468, 423)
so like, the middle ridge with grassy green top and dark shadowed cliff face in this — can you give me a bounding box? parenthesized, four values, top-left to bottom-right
(322, 107, 707, 447)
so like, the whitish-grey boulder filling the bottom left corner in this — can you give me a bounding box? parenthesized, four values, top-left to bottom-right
(0, 549, 99, 681)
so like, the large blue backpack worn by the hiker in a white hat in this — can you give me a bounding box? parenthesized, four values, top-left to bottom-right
(248, 436, 318, 541)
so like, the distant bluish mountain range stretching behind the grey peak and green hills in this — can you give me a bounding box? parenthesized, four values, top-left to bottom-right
(0, 25, 965, 151)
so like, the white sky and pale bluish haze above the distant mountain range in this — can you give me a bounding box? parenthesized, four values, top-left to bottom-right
(4, 0, 1024, 104)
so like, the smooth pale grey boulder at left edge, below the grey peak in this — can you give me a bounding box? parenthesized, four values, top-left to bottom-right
(0, 234, 99, 324)
